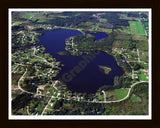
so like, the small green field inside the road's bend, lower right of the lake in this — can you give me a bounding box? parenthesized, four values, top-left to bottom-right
(115, 88, 129, 100)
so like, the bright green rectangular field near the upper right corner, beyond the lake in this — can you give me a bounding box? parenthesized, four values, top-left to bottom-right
(128, 21, 145, 34)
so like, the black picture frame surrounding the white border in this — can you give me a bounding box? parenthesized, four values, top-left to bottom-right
(0, 0, 160, 128)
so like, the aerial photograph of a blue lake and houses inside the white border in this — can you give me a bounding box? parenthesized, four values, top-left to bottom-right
(9, 9, 151, 119)
